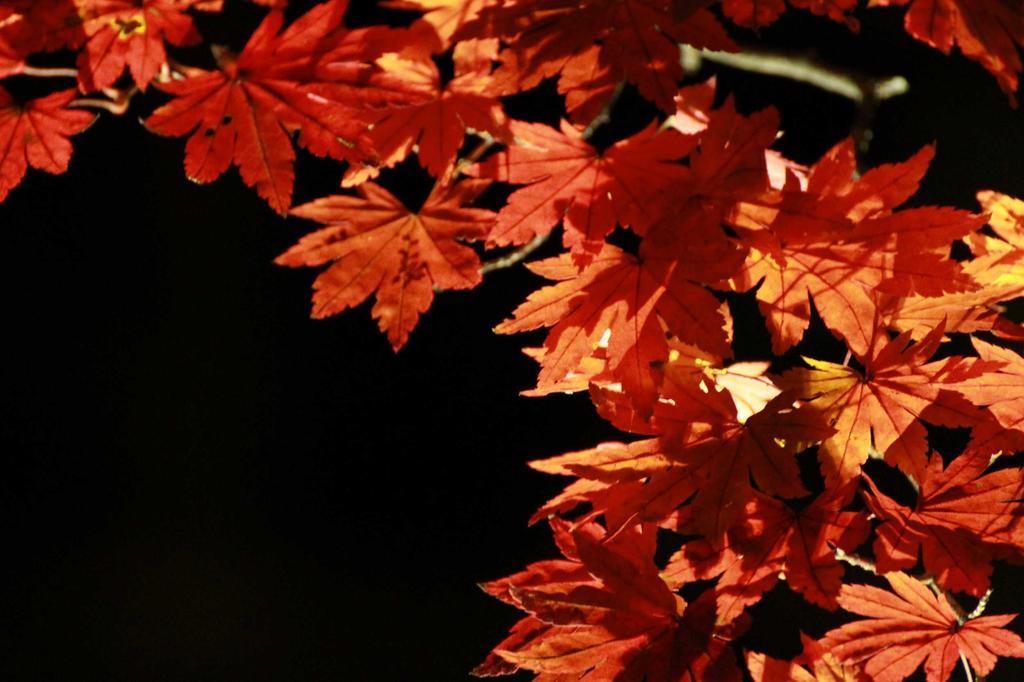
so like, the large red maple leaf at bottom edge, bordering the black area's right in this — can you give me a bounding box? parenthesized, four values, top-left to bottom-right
(474, 523, 742, 682)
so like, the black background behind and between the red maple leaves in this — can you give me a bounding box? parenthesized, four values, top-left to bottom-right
(0, 0, 1024, 680)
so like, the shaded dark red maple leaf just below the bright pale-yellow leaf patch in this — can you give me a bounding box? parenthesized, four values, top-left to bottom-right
(530, 366, 833, 538)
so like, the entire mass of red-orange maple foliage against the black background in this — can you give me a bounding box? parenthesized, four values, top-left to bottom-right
(6, 0, 1024, 682)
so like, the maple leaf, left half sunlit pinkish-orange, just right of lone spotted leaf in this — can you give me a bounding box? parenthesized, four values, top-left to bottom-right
(469, 116, 694, 254)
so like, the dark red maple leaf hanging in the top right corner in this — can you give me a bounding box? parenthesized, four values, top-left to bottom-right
(868, 0, 1024, 105)
